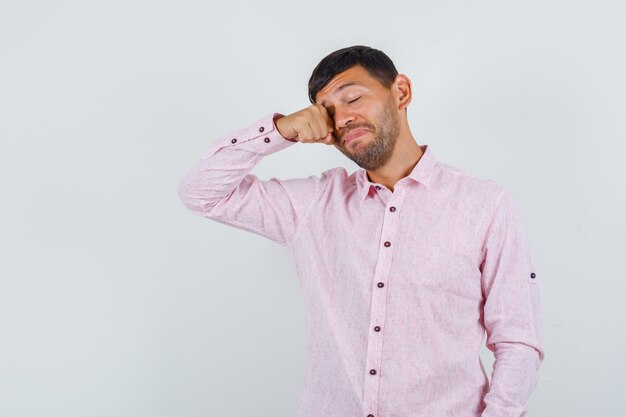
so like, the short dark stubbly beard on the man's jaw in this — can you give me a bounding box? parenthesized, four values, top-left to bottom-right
(339, 96, 400, 171)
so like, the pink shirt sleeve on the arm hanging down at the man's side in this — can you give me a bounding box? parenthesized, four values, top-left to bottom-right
(481, 189, 544, 417)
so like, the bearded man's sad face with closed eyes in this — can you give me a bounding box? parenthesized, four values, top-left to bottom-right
(316, 65, 400, 171)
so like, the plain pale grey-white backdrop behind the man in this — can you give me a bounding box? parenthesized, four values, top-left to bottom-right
(0, 0, 626, 417)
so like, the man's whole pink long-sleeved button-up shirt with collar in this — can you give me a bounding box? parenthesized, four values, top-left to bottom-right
(178, 113, 544, 417)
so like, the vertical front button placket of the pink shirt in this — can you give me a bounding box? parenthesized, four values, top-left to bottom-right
(363, 186, 404, 415)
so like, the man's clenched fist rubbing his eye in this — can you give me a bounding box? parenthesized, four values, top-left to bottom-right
(275, 104, 336, 145)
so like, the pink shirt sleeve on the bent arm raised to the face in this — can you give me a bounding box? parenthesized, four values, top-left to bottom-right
(177, 113, 325, 246)
